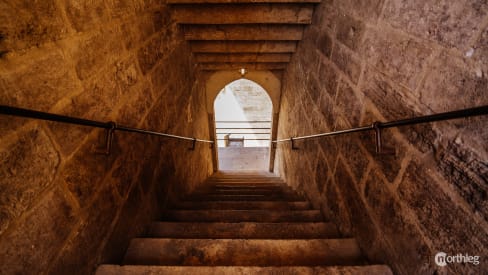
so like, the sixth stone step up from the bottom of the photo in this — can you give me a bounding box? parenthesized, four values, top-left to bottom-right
(182, 193, 305, 201)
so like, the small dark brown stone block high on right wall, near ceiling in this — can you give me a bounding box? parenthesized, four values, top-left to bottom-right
(336, 14, 366, 51)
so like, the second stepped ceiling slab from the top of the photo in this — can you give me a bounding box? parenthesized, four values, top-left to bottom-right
(184, 24, 303, 41)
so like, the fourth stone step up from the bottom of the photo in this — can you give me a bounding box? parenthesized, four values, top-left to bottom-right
(163, 210, 324, 222)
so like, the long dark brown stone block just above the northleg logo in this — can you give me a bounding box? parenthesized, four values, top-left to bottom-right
(398, 159, 488, 274)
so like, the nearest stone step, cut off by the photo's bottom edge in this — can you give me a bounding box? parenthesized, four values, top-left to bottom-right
(96, 265, 393, 275)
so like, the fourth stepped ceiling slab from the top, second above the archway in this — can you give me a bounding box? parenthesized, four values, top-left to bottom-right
(195, 53, 291, 63)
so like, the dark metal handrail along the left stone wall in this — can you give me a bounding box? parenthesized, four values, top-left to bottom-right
(0, 105, 214, 151)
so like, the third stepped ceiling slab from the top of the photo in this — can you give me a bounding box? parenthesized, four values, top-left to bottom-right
(191, 40, 296, 53)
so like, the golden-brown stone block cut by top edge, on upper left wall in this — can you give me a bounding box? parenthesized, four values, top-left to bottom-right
(64, 0, 109, 32)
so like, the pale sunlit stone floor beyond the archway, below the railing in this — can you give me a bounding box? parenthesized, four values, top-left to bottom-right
(218, 147, 269, 171)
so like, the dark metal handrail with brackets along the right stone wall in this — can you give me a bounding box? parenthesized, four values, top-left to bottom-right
(271, 105, 488, 153)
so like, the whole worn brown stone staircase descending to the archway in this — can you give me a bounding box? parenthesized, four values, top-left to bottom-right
(96, 172, 391, 275)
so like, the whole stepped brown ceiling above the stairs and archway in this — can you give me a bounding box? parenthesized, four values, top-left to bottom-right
(168, 0, 320, 71)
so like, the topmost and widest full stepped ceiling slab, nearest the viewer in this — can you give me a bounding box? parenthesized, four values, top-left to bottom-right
(172, 4, 313, 24)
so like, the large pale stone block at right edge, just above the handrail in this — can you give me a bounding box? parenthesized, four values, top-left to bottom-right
(418, 52, 488, 112)
